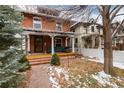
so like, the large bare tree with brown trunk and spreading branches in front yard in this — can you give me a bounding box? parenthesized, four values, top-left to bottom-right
(52, 5, 124, 75)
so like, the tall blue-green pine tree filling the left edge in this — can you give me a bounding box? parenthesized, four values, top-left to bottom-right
(0, 5, 27, 87)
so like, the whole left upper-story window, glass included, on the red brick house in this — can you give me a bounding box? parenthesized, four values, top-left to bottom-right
(33, 17, 42, 30)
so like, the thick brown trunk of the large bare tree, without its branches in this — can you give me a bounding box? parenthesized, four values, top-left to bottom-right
(103, 10, 113, 75)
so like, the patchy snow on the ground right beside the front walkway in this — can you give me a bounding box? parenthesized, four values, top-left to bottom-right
(48, 66, 69, 88)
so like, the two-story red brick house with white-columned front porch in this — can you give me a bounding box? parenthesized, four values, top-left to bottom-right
(22, 10, 74, 54)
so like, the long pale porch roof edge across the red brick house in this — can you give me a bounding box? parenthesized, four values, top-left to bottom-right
(22, 28, 74, 37)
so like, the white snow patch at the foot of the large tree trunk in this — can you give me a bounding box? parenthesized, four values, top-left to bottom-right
(92, 71, 119, 88)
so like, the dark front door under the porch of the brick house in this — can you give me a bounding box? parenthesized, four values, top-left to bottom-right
(34, 36, 43, 53)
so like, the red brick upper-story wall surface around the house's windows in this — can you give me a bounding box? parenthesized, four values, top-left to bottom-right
(22, 14, 70, 32)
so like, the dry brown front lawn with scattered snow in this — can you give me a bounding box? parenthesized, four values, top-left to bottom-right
(58, 59, 124, 88)
